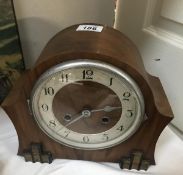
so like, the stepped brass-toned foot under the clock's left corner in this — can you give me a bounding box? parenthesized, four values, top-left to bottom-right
(23, 143, 53, 164)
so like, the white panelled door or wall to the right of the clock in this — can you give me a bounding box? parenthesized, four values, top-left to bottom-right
(115, 0, 183, 133)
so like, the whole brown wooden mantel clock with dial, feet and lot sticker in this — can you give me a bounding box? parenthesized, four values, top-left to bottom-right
(2, 24, 173, 170)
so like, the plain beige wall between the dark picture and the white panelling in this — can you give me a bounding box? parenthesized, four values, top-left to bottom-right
(14, 0, 115, 67)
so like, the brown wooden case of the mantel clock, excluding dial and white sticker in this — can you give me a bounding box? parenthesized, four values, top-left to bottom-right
(2, 25, 173, 169)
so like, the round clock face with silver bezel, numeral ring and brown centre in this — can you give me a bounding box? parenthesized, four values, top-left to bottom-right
(31, 60, 144, 149)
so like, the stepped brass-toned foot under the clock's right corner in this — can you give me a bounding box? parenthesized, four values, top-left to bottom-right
(119, 151, 150, 171)
